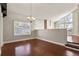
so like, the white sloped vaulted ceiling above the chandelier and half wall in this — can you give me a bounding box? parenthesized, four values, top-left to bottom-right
(8, 3, 77, 19)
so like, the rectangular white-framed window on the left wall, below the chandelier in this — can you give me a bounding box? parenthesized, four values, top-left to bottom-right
(14, 21, 31, 35)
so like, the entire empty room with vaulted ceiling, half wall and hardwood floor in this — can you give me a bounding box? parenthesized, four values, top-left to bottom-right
(0, 3, 79, 56)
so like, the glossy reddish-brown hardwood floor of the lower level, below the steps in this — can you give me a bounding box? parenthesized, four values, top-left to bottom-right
(2, 39, 79, 56)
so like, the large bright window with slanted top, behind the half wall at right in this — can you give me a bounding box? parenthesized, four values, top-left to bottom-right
(55, 14, 73, 35)
